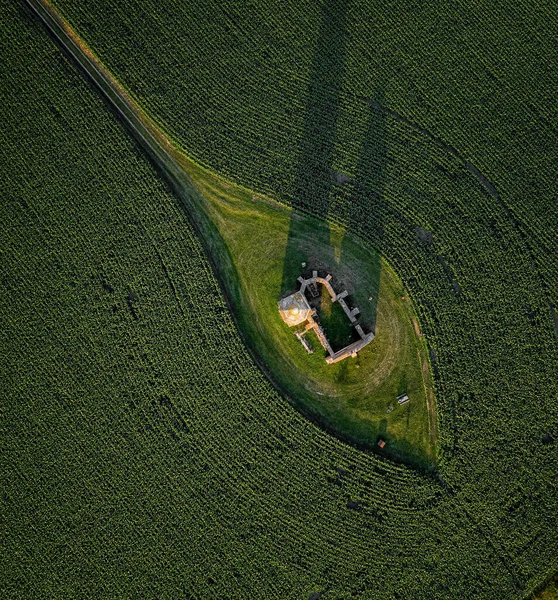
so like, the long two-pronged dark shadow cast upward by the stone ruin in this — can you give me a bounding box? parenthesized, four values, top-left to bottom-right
(280, 0, 386, 338)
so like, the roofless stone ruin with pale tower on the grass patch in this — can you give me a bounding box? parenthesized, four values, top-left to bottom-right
(278, 271, 374, 364)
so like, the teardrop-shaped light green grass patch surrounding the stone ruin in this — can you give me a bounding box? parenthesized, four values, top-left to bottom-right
(181, 159, 435, 466)
